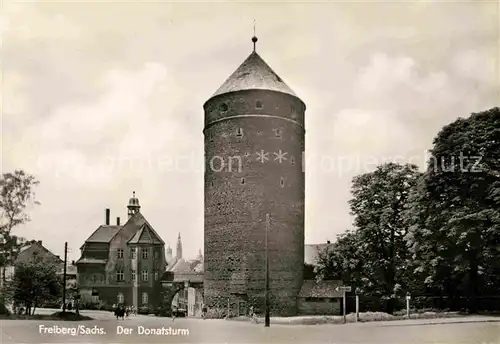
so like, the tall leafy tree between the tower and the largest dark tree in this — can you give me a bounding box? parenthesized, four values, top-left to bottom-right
(350, 163, 421, 296)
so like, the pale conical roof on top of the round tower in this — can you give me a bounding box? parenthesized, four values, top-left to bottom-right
(212, 51, 297, 97)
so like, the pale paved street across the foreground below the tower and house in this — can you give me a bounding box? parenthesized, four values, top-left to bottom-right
(0, 312, 500, 344)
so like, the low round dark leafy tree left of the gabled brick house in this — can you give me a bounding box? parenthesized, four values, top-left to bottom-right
(10, 256, 63, 314)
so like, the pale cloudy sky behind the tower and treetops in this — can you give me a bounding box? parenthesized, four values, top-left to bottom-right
(0, 0, 500, 259)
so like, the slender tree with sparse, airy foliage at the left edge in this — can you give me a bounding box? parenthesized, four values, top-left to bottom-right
(0, 170, 39, 284)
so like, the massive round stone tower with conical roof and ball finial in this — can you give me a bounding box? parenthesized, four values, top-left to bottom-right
(203, 37, 306, 315)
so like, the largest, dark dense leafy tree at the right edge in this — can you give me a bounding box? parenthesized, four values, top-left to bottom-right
(408, 108, 500, 311)
